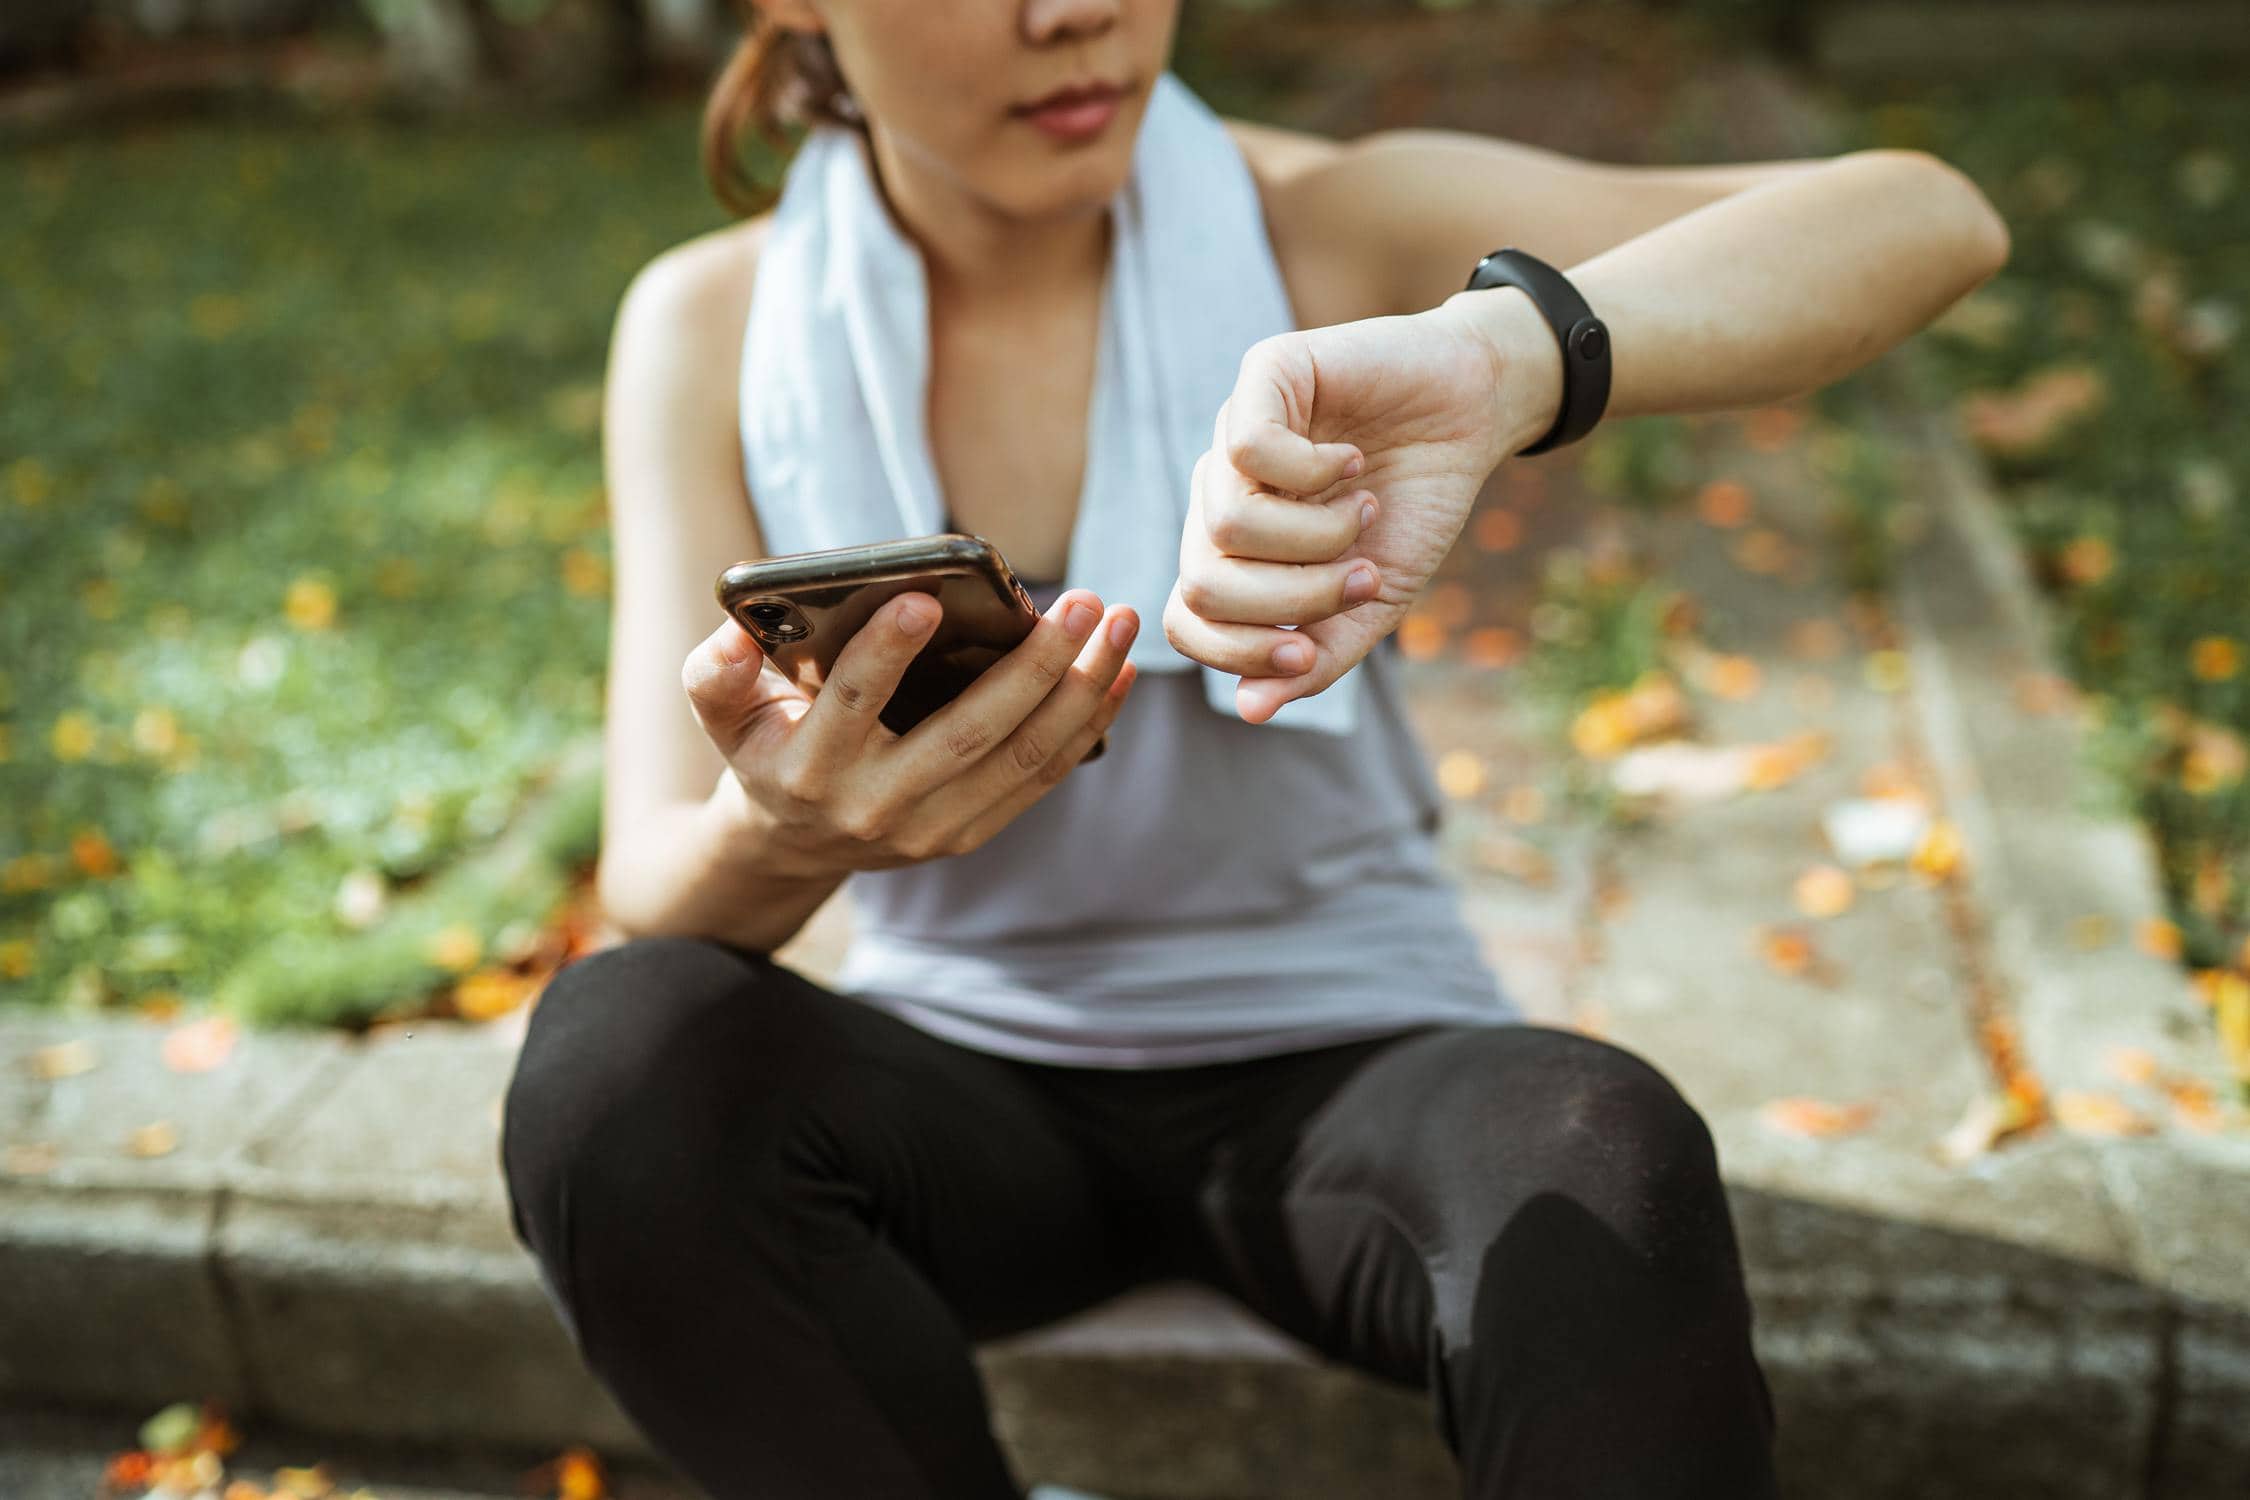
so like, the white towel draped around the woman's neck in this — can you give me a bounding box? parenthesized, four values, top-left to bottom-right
(740, 72, 1359, 733)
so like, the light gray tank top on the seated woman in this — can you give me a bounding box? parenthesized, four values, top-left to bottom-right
(833, 568, 1523, 1068)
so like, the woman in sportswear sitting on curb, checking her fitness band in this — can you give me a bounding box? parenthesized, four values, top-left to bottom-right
(502, 0, 2007, 1500)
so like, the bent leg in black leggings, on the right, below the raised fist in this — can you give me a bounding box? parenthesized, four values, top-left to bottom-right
(1199, 1025, 1775, 1500)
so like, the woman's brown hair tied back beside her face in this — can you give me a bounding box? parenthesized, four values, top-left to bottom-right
(702, 0, 866, 218)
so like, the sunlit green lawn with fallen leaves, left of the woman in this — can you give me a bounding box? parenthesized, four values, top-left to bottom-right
(0, 106, 747, 1019)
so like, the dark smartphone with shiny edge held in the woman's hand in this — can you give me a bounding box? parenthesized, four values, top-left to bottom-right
(716, 531, 1109, 762)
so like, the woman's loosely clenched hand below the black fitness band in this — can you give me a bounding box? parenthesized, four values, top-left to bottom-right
(1163, 292, 1562, 724)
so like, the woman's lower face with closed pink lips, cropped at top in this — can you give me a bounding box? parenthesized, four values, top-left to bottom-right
(783, 0, 1179, 218)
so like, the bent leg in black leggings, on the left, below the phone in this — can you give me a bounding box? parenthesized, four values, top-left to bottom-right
(502, 938, 1136, 1500)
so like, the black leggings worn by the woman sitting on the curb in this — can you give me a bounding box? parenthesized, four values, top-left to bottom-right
(500, 938, 1775, 1500)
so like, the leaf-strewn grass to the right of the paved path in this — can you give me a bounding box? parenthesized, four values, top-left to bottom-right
(1859, 79, 2250, 967)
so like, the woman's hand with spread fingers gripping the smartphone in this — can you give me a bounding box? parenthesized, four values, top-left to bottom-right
(680, 589, 1139, 875)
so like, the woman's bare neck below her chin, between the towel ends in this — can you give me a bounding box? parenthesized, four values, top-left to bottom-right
(871, 130, 1109, 315)
